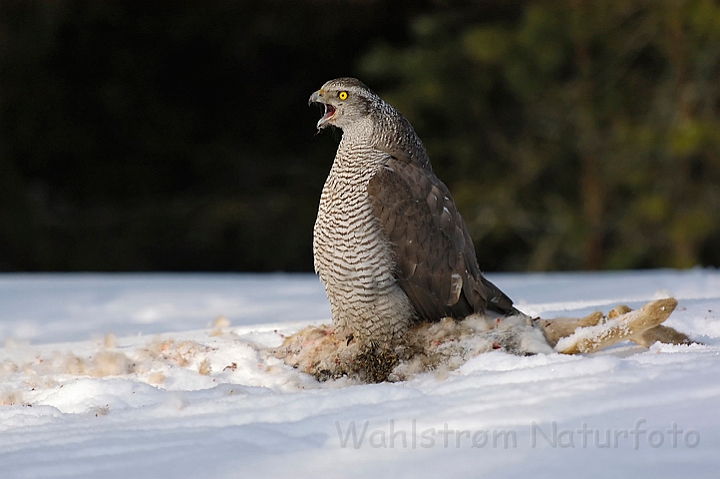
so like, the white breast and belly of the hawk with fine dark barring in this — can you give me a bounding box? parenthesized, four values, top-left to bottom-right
(313, 122, 415, 342)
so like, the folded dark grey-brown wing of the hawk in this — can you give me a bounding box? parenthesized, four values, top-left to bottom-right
(368, 152, 518, 321)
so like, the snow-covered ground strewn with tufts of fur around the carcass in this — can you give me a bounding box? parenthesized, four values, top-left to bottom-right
(0, 269, 720, 479)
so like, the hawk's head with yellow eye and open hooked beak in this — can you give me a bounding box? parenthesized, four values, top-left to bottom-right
(308, 78, 382, 130)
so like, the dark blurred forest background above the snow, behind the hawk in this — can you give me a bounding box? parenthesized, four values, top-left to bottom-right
(0, 0, 720, 271)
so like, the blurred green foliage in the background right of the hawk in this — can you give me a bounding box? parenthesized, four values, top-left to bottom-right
(362, 0, 720, 270)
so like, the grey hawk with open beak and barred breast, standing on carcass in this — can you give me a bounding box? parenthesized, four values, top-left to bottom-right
(309, 78, 518, 345)
